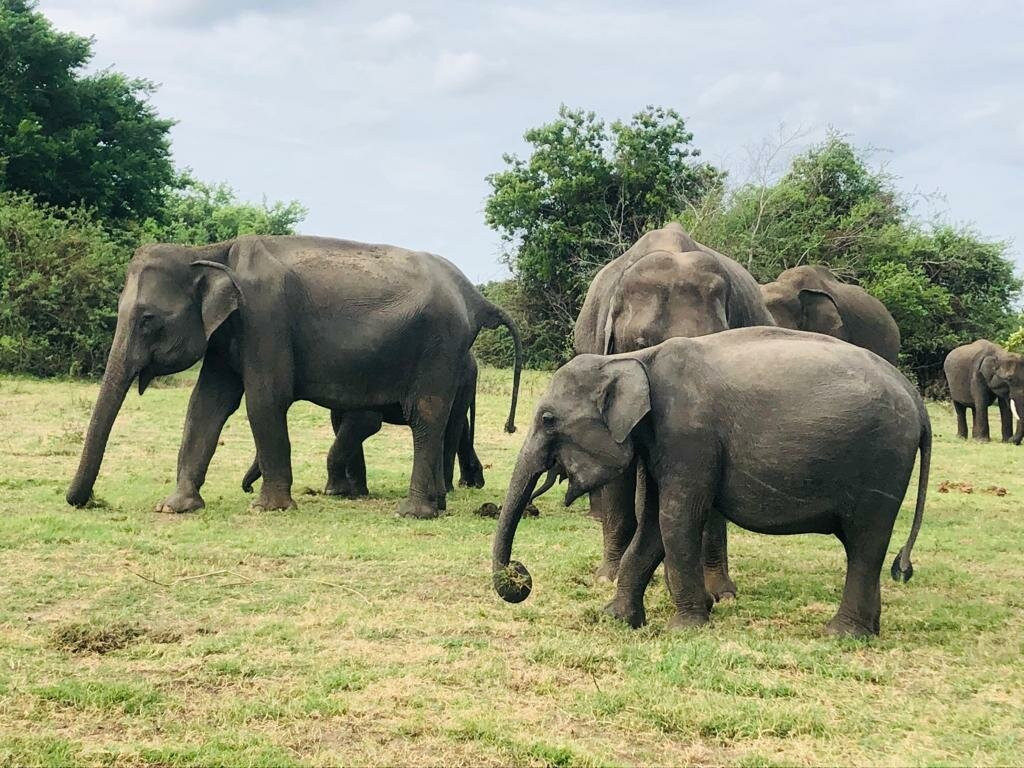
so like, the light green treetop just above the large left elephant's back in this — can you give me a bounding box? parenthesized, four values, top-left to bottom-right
(139, 173, 306, 246)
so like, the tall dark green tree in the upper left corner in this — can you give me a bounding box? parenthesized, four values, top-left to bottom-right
(0, 0, 173, 223)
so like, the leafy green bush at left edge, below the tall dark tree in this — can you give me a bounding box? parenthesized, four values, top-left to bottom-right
(0, 193, 131, 376)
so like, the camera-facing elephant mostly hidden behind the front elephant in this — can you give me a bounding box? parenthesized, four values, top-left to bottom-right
(573, 222, 775, 599)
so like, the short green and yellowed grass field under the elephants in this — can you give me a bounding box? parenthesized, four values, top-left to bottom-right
(0, 371, 1024, 766)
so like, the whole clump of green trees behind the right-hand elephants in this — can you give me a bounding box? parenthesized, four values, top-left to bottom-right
(480, 106, 1021, 385)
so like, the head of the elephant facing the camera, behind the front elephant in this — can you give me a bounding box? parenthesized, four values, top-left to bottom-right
(603, 251, 729, 354)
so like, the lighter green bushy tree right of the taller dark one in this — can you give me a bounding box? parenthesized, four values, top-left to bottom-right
(680, 134, 1021, 386)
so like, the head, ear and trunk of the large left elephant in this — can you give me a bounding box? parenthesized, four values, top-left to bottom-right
(67, 245, 242, 507)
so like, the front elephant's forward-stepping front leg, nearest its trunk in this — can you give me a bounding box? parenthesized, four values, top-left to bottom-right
(604, 476, 665, 628)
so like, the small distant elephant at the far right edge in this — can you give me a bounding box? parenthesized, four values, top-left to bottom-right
(942, 339, 1024, 445)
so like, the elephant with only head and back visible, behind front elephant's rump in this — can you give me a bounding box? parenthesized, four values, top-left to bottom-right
(761, 264, 900, 366)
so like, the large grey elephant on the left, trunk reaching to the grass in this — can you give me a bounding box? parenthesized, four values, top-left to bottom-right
(67, 236, 522, 518)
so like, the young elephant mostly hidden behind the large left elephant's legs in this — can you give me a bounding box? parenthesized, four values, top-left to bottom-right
(242, 354, 484, 499)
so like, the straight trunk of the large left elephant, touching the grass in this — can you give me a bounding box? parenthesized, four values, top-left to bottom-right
(66, 329, 136, 507)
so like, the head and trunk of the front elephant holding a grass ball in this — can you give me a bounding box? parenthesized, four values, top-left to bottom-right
(492, 354, 650, 602)
